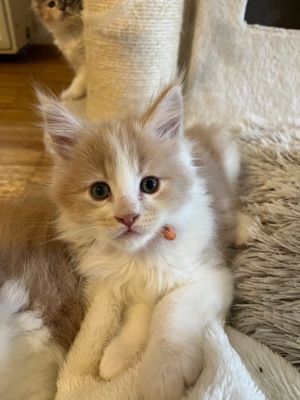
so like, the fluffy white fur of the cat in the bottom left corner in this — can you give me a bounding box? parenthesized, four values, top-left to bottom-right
(0, 281, 64, 400)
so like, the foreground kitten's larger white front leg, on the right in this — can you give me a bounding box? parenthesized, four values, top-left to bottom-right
(138, 269, 232, 400)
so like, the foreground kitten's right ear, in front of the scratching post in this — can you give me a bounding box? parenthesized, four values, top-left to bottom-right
(145, 85, 183, 139)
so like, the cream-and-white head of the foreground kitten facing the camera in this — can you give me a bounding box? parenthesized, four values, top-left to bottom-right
(38, 86, 196, 251)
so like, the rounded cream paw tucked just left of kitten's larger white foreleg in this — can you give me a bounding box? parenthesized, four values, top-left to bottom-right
(100, 338, 141, 380)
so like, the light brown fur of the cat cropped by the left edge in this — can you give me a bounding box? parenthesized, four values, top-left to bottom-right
(0, 194, 82, 348)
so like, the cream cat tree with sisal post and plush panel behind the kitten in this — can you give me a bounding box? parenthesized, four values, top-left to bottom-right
(85, 0, 300, 121)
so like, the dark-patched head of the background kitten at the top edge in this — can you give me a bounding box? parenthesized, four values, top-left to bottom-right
(32, 0, 82, 28)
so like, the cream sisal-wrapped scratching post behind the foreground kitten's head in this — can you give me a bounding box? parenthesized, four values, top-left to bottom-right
(84, 0, 184, 119)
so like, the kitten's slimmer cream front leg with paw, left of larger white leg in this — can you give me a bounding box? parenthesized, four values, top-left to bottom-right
(100, 303, 152, 380)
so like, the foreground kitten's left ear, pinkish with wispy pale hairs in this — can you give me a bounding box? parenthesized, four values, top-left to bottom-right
(35, 89, 82, 158)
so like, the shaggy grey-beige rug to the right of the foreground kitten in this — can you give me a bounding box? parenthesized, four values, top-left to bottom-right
(232, 119, 300, 370)
